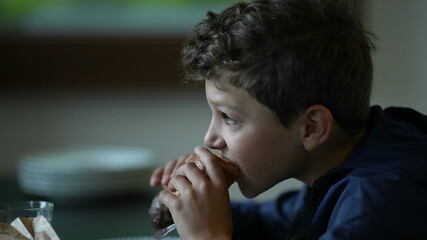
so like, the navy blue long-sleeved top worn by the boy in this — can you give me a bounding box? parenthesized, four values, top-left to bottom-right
(232, 106, 427, 240)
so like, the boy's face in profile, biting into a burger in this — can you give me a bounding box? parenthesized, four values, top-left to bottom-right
(205, 81, 304, 198)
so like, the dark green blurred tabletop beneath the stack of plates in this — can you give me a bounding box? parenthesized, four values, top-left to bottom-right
(0, 178, 177, 240)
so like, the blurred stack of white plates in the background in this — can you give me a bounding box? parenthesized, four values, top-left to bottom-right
(18, 148, 158, 199)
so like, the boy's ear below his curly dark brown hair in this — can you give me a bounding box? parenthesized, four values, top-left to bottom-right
(301, 105, 334, 151)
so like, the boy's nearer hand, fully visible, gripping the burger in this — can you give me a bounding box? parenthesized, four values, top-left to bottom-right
(159, 148, 232, 239)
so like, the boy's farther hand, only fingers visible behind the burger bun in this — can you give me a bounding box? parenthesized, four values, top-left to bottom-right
(150, 154, 195, 187)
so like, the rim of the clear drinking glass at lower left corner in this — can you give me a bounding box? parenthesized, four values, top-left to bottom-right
(0, 200, 54, 212)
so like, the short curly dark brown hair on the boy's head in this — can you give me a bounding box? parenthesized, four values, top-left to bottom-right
(182, 0, 374, 129)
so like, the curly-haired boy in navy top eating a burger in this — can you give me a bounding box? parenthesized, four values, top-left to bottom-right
(151, 0, 427, 240)
